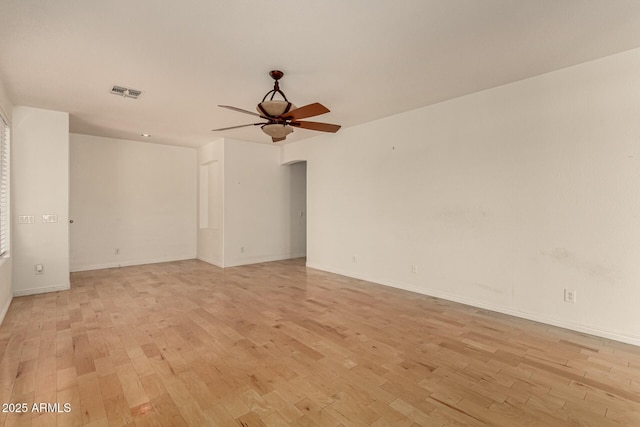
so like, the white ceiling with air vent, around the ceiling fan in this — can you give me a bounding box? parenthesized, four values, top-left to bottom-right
(0, 0, 640, 146)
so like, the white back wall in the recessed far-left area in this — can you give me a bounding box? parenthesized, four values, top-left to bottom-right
(70, 134, 197, 271)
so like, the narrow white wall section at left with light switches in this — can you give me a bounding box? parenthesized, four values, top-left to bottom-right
(11, 107, 69, 295)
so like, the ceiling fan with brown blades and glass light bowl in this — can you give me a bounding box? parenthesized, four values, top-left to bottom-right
(213, 70, 340, 142)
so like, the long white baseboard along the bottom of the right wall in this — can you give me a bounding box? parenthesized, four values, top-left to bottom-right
(307, 262, 640, 346)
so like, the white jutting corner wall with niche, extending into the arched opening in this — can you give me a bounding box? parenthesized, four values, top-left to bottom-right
(198, 139, 306, 267)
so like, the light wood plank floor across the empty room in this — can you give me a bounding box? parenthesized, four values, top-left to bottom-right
(0, 260, 640, 427)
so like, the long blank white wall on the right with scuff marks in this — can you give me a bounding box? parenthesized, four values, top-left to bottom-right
(282, 50, 640, 344)
